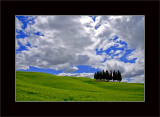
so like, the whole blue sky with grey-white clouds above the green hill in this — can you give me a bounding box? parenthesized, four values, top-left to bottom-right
(15, 15, 145, 83)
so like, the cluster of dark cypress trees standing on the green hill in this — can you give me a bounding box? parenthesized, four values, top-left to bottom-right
(94, 70, 122, 82)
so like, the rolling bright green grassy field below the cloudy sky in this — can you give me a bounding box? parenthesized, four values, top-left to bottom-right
(16, 71, 144, 101)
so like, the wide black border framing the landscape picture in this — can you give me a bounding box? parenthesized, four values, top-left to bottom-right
(1, 1, 159, 116)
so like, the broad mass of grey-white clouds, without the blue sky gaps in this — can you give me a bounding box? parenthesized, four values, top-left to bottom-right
(16, 16, 144, 82)
